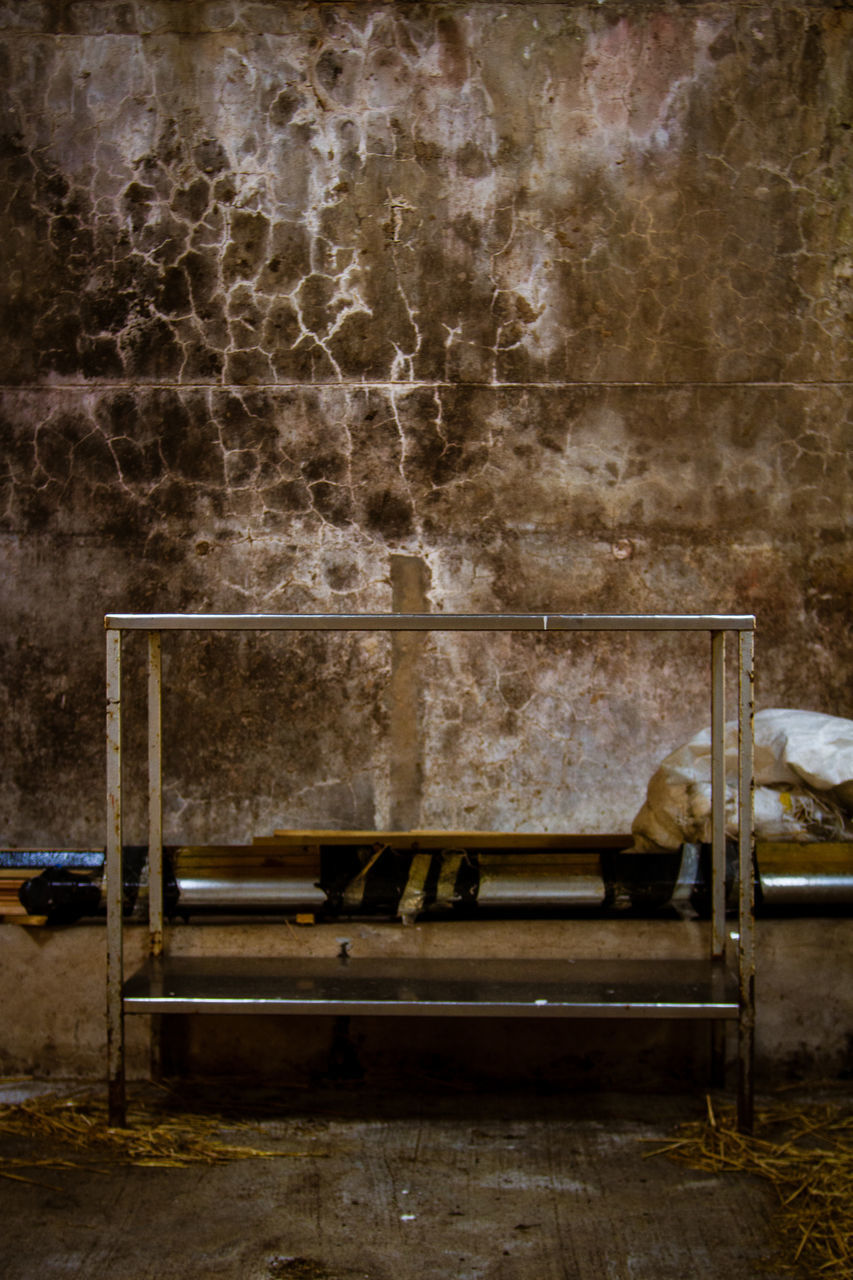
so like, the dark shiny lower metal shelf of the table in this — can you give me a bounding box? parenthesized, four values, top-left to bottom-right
(122, 957, 739, 1019)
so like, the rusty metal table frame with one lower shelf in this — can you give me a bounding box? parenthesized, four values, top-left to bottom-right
(105, 613, 756, 1130)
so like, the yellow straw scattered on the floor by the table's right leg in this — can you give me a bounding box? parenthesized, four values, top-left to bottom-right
(648, 1097, 853, 1280)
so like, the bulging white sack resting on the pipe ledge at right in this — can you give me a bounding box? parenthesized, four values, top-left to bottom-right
(631, 709, 853, 850)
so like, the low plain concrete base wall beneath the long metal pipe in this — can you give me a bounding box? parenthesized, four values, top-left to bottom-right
(0, 919, 853, 1088)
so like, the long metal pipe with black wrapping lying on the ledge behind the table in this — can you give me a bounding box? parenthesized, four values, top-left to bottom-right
(19, 832, 853, 924)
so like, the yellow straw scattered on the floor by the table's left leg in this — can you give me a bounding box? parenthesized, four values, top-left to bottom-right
(0, 1093, 315, 1190)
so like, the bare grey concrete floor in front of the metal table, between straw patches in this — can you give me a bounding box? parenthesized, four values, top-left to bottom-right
(0, 1083, 799, 1280)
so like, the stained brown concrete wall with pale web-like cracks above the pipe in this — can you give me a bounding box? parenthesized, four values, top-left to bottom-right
(0, 0, 853, 844)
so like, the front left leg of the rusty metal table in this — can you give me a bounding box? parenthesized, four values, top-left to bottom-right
(104, 628, 126, 1126)
